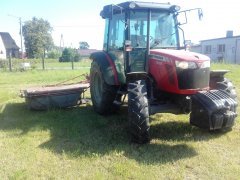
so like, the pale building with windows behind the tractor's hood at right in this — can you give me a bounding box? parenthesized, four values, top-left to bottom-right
(191, 31, 240, 64)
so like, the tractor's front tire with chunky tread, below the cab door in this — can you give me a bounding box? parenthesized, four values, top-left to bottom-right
(128, 80, 150, 144)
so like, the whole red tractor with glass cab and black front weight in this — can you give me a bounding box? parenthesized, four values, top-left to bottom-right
(90, 1, 237, 143)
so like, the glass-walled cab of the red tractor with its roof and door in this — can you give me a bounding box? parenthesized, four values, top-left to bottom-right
(101, 2, 180, 73)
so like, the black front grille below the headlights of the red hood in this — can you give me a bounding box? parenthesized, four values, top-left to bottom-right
(177, 68, 210, 89)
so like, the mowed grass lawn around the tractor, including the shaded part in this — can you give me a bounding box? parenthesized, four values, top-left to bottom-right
(0, 64, 240, 179)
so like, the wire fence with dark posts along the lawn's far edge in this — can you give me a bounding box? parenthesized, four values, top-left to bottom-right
(0, 59, 91, 71)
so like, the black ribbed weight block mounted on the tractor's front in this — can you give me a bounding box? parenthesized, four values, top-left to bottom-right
(190, 90, 237, 130)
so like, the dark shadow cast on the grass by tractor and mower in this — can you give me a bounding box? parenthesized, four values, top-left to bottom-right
(0, 103, 227, 164)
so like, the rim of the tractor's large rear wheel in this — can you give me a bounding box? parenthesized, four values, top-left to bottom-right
(93, 73, 103, 104)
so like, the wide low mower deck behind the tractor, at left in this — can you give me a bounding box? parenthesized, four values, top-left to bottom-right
(21, 83, 89, 110)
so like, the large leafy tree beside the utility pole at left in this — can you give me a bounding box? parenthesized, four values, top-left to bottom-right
(22, 17, 53, 58)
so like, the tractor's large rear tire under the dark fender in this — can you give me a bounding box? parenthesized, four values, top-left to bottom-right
(90, 61, 119, 115)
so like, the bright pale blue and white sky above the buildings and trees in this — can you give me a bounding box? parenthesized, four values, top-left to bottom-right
(0, 0, 240, 49)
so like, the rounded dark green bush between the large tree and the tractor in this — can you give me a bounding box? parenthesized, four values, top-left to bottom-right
(59, 48, 81, 62)
